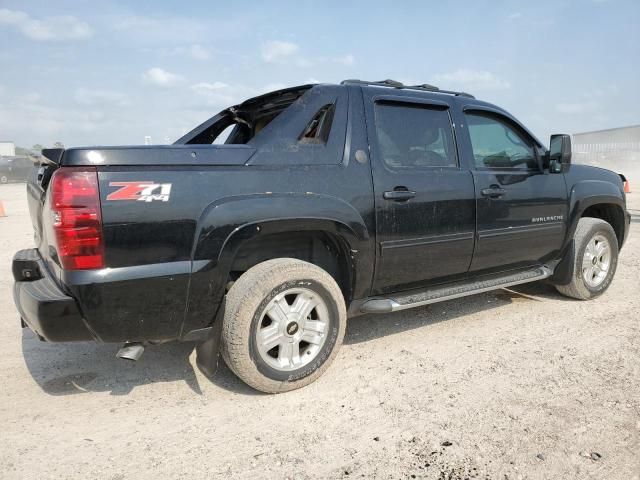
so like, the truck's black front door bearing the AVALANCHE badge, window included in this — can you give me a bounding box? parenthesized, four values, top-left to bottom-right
(464, 109, 568, 272)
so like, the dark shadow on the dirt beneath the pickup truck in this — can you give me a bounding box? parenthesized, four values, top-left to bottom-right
(22, 282, 570, 396)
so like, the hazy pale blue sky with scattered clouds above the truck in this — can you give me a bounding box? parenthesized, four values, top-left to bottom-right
(0, 0, 640, 147)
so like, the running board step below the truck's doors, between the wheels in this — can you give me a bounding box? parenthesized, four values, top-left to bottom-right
(360, 266, 553, 313)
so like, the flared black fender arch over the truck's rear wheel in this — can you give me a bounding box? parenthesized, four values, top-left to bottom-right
(182, 192, 375, 333)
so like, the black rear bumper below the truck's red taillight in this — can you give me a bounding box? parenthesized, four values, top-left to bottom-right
(12, 249, 94, 342)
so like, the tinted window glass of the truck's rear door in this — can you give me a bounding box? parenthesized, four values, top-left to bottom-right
(375, 103, 458, 168)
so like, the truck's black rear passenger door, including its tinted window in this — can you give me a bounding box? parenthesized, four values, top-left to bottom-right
(365, 89, 475, 294)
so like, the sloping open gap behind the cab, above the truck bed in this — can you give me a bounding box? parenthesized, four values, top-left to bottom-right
(175, 85, 312, 145)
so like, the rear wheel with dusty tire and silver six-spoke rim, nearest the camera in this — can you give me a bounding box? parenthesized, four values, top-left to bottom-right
(222, 258, 347, 393)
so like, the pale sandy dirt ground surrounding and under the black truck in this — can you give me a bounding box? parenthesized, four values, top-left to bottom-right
(0, 185, 640, 480)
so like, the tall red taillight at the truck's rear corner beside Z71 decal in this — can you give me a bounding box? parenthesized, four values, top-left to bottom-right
(49, 167, 104, 270)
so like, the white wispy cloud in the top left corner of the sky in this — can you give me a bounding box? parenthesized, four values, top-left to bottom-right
(0, 8, 93, 41)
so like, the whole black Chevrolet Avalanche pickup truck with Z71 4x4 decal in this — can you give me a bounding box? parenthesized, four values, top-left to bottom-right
(13, 80, 630, 392)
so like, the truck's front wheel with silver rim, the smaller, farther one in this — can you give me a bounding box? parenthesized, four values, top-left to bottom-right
(555, 217, 618, 300)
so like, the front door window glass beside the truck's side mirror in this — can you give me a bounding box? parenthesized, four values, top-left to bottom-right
(466, 113, 538, 170)
